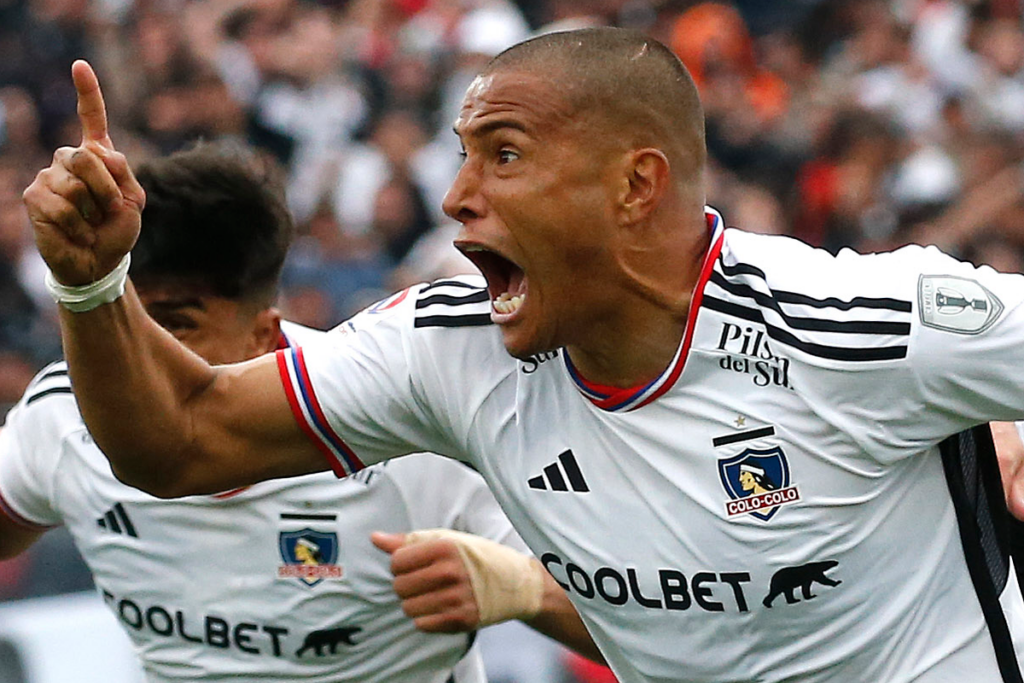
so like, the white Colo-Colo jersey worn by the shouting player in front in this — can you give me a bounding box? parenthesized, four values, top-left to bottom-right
(278, 212, 1024, 683)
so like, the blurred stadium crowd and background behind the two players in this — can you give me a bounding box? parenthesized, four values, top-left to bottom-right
(0, 0, 1024, 683)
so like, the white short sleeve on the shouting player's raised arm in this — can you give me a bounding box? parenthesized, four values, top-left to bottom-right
(278, 284, 489, 476)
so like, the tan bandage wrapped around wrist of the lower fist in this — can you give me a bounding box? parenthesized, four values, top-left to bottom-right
(406, 528, 546, 627)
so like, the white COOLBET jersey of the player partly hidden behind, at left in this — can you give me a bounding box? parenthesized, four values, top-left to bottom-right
(0, 326, 524, 683)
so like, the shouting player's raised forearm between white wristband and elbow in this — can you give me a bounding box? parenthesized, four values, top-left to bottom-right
(60, 284, 215, 489)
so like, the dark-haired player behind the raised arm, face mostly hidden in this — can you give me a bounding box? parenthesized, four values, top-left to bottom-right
(0, 144, 585, 683)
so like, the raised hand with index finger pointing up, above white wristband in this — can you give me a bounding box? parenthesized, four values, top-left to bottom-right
(23, 59, 145, 286)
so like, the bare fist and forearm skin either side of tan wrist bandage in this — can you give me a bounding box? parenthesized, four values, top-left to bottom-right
(371, 532, 604, 664)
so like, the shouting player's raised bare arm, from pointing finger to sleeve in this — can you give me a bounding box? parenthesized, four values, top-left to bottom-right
(24, 60, 327, 497)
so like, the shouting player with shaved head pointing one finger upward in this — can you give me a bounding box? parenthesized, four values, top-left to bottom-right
(26, 29, 1024, 683)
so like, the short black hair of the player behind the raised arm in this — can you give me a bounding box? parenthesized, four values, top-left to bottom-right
(131, 142, 294, 305)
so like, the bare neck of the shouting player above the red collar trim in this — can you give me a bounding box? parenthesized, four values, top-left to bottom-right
(566, 208, 711, 388)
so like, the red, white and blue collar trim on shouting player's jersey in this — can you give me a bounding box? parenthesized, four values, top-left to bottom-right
(562, 207, 725, 413)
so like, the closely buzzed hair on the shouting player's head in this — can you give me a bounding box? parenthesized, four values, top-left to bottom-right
(483, 28, 707, 180)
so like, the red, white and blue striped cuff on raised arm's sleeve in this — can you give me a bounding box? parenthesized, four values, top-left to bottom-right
(275, 348, 365, 476)
